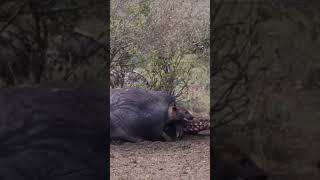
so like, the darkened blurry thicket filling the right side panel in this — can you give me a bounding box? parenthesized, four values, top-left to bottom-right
(211, 0, 320, 180)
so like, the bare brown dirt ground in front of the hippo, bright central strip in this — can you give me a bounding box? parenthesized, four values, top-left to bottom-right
(110, 132, 210, 180)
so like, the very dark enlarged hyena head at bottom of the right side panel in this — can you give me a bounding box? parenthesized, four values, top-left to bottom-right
(213, 145, 268, 180)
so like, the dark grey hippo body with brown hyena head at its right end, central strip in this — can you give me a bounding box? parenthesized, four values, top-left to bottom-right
(110, 88, 188, 142)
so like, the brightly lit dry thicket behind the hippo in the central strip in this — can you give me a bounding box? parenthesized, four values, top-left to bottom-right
(110, 0, 210, 114)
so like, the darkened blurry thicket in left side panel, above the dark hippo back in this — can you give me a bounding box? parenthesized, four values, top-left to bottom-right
(0, 0, 108, 87)
